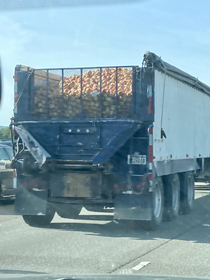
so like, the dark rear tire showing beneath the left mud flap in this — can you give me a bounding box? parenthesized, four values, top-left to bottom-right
(22, 205, 55, 227)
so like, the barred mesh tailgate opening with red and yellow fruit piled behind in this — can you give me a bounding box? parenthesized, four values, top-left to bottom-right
(32, 67, 133, 118)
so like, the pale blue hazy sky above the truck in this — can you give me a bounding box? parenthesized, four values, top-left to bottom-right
(0, 0, 210, 126)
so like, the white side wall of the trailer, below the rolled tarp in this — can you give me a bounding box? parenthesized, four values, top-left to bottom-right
(153, 70, 210, 161)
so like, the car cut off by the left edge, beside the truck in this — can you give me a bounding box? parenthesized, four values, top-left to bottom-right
(0, 144, 16, 201)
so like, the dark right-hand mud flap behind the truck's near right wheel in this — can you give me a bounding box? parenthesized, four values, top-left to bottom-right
(114, 193, 152, 221)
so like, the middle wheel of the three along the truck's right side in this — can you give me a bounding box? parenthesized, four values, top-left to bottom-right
(164, 174, 180, 221)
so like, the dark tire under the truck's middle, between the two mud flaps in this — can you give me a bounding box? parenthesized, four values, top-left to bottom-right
(56, 204, 82, 219)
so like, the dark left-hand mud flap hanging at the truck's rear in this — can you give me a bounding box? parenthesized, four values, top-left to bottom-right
(15, 187, 47, 215)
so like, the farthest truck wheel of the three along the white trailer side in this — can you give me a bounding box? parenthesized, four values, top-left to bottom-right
(180, 172, 195, 214)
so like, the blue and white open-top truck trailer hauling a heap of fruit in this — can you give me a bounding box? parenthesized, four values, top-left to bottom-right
(11, 52, 210, 229)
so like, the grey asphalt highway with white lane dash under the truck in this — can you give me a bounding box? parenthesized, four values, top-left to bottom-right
(0, 184, 210, 277)
